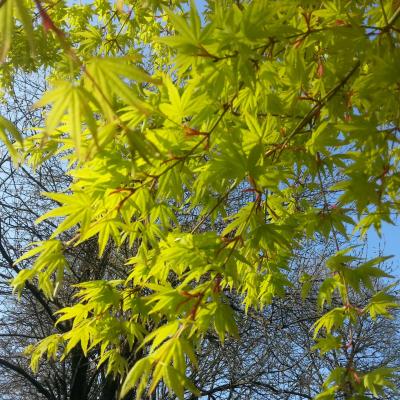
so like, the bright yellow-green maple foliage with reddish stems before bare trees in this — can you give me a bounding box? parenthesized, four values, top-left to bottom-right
(0, 0, 400, 399)
